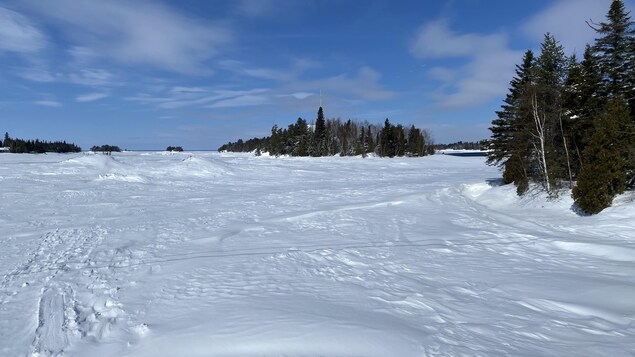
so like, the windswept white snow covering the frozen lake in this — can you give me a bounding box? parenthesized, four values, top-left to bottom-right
(0, 153, 635, 357)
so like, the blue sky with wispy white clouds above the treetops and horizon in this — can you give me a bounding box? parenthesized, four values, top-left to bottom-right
(0, 0, 633, 150)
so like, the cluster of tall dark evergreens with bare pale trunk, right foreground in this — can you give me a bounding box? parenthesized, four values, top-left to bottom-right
(488, 0, 635, 214)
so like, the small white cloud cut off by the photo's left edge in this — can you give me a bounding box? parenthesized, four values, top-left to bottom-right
(0, 7, 46, 54)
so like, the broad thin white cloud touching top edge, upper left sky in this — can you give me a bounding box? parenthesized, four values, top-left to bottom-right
(27, 0, 232, 73)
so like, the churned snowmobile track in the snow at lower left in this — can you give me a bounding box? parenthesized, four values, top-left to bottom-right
(0, 228, 140, 356)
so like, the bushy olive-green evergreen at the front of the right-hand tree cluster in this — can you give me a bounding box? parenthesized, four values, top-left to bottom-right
(573, 97, 634, 214)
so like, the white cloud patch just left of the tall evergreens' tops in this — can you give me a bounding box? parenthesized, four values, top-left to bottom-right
(410, 20, 522, 109)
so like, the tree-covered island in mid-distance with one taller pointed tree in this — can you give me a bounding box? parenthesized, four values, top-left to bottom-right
(218, 107, 434, 157)
